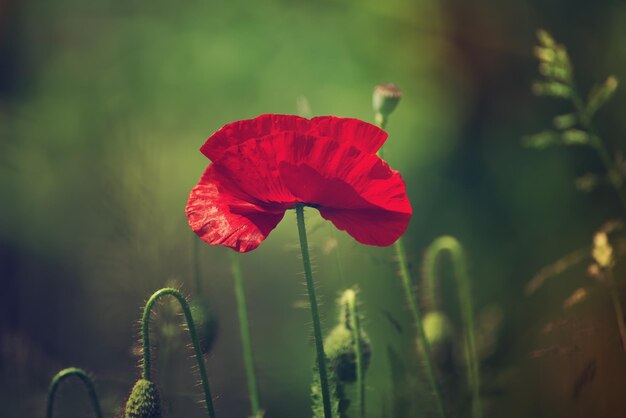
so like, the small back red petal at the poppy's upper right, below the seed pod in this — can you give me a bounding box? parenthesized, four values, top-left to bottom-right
(311, 116, 387, 154)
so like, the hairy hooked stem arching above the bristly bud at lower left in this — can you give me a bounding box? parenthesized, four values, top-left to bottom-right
(141, 287, 215, 418)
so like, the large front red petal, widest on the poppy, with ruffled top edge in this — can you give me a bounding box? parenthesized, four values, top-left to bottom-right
(209, 132, 412, 246)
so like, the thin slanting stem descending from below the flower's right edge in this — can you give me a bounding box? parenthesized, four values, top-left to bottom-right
(394, 238, 445, 418)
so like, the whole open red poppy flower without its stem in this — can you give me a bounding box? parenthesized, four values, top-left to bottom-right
(186, 115, 412, 252)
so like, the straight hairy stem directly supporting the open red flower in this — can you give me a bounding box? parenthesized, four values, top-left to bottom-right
(296, 203, 332, 418)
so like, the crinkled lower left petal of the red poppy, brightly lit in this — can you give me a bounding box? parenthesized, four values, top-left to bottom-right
(185, 170, 284, 253)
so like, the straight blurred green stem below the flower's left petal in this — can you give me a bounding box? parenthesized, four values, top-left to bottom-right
(229, 252, 261, 417)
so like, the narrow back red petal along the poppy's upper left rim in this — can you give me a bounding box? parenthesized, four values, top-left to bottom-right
(200, 114, 311, 161)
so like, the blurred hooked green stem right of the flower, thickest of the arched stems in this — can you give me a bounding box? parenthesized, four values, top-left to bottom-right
(423, 236, 483, 418)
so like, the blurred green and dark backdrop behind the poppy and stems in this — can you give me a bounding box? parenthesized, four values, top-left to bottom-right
(0, 0, 626, 418)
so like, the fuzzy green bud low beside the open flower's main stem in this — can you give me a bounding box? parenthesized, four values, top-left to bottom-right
(324, 324, 372, 383)
